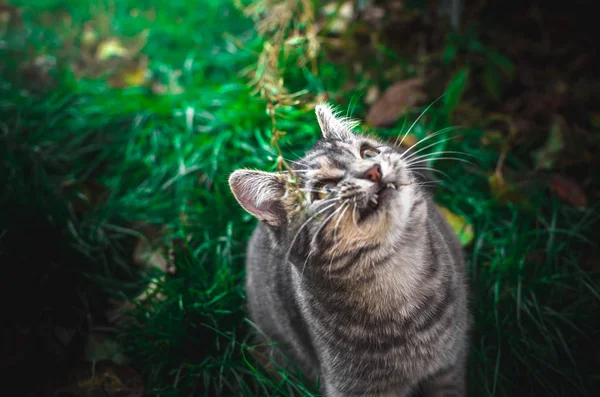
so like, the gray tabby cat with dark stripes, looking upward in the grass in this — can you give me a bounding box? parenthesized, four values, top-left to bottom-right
(229, 104, 469, 397)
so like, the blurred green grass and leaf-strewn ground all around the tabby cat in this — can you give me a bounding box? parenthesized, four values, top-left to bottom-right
(0, 0, 600, 396)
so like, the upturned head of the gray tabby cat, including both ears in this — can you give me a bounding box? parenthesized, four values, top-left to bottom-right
(229, 104, 423, 260)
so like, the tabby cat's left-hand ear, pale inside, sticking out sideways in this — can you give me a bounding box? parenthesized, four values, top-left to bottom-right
(229, 170, 286, 227)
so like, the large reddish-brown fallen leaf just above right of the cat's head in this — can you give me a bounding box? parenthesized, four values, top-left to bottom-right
(367, 78, 425, 127)
